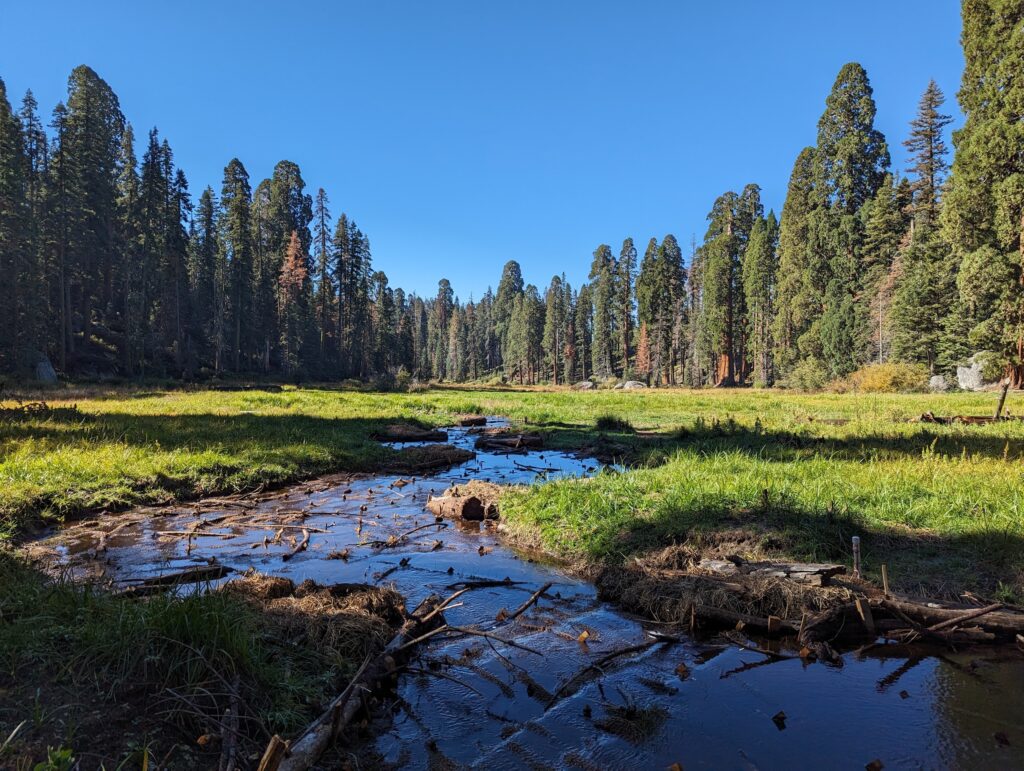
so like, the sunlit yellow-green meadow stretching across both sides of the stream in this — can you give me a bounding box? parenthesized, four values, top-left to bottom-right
(6, 388, 1024, 598)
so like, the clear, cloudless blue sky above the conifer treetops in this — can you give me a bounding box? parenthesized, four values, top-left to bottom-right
(0, 0, 963, 299)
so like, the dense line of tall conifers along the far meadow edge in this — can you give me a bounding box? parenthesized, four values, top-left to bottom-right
(0, 0, 1024, 386)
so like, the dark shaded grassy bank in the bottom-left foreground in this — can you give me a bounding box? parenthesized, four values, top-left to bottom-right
(0, 550, 358, 767)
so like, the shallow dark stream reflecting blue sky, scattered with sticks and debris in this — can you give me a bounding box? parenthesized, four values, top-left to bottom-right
(25, 421, 1024, 769)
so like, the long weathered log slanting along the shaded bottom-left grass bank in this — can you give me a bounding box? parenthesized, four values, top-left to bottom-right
(259, 596, 437, 771)
